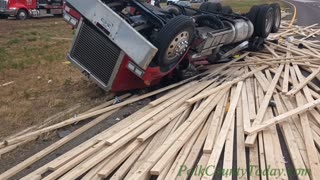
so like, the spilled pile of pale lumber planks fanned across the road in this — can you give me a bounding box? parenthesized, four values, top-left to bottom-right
(0, 27, 320, 180)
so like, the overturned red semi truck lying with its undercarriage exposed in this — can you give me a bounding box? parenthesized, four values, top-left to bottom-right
(64, 0, 281, 91)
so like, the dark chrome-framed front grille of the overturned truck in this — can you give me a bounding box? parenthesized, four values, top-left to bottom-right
(69, 21, 122, 90)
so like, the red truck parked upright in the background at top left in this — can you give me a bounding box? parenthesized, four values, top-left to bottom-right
(0, 0, 64, 20)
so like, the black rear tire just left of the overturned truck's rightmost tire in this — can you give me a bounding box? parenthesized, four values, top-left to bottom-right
(254, 5, 274, 38)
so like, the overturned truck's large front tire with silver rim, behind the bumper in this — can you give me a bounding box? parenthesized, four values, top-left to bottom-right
(154, 15, 195, 72)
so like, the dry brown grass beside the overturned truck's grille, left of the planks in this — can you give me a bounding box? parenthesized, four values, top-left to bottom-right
(0, 18, 112, 139)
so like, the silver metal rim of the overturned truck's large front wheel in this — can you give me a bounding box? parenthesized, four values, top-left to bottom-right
(166, 31, 189, 62)
